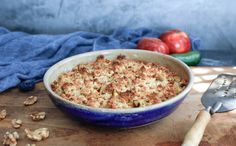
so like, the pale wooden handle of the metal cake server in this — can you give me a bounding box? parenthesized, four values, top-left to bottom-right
(182, 110, 211, 146)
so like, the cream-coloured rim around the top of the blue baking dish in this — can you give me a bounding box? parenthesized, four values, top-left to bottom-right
(43, 49, 194, 114)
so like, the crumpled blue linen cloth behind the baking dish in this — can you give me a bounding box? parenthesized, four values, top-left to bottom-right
(0, 27, 200, 92)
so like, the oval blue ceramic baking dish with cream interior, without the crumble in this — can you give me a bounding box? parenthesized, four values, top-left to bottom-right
(44, 49, 193, 128)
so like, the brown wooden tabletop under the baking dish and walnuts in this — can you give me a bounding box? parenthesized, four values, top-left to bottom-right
(0, 67, 236, 146)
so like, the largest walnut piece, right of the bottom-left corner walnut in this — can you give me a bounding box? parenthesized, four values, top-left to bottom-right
(25, 128, 49, 141)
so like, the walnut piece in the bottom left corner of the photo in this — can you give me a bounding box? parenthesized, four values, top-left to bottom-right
(2, 131, 19, 146)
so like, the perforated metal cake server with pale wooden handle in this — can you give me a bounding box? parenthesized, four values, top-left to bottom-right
(182, 74, 236, 146)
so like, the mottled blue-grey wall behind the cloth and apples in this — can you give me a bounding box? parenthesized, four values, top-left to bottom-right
(0, 0, 236, 50)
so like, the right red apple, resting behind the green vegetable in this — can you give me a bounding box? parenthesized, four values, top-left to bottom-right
(160, 29, 191, 53)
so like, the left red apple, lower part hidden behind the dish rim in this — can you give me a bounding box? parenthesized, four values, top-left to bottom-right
(137, 38, 170, 54)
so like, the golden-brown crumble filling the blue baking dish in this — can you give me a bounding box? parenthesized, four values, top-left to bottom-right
(51, 55, 187, 109)
